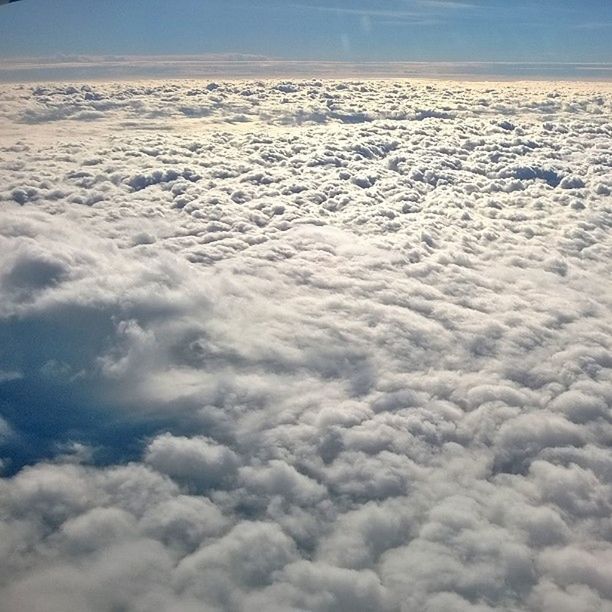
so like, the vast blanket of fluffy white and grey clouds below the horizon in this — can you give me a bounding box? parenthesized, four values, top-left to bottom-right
(0, 81, 612, 612)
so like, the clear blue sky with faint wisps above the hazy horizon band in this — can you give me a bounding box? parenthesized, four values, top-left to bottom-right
(0, 0, 612, 62)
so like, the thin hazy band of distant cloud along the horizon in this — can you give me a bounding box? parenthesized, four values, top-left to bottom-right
(0, 53, 612, 83)
